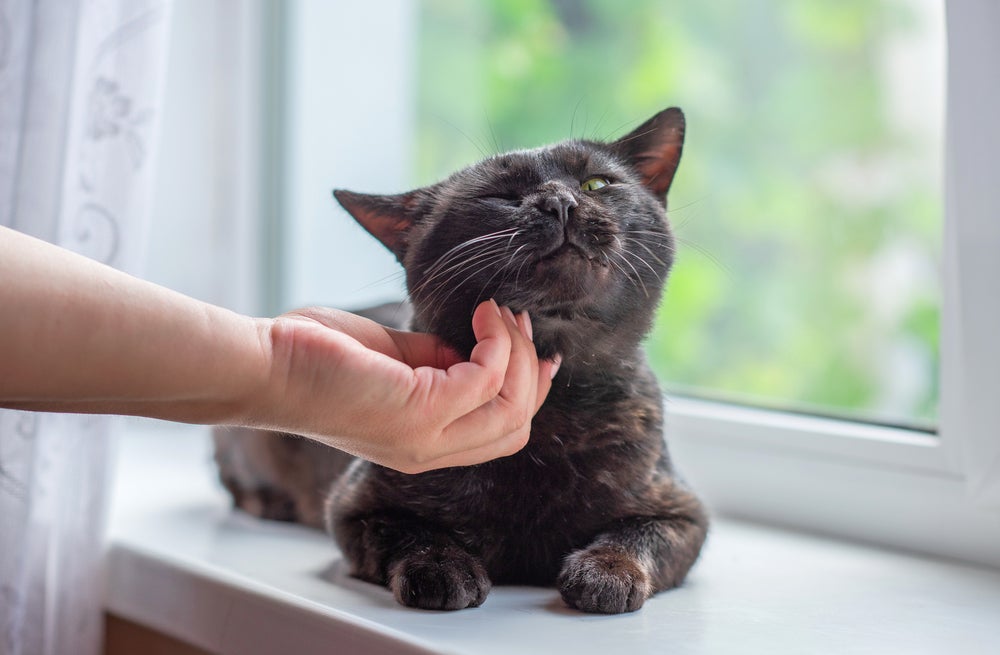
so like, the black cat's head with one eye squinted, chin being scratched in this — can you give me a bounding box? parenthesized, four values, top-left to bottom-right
(334, 108, 684, 364)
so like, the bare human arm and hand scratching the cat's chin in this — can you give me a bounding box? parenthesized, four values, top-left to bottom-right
(0, 227, 557, 472)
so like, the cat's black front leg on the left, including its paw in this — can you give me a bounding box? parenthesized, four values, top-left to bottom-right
(333, 513, 492, 610)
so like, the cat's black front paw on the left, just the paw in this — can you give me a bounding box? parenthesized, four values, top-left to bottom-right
(389, 546, 493, 610)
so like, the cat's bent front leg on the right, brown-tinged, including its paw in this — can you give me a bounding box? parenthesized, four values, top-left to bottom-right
(557, 495, 708, 614)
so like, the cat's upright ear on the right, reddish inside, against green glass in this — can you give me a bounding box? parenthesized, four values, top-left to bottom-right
(611, 107, 684, 198)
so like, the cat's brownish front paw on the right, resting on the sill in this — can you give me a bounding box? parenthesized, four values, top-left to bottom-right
(556, 548, 653, 614)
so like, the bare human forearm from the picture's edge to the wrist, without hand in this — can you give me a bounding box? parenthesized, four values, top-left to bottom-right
(0, 227, 270, 422)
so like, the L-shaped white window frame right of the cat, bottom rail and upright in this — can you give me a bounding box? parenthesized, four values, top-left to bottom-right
(667, 0, 1000, 566)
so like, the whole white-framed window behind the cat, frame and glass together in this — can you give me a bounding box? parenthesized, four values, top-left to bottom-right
(145, 0, 1000, 564)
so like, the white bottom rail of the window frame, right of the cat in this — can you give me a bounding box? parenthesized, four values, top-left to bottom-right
(666, 397, 1000, 568)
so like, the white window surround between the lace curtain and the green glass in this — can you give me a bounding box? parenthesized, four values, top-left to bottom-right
(146, 0, 416, 313)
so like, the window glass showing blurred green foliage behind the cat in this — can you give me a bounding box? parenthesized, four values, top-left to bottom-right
(414, 0, 944, 427)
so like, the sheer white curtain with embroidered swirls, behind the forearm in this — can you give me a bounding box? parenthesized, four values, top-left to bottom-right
(0, 0, 170, 655)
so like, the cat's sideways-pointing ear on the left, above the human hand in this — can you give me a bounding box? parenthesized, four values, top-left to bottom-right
(333, 189, 422, 262)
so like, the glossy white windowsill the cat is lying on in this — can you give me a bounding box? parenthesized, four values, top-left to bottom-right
(107, 423, 1000, 655)
